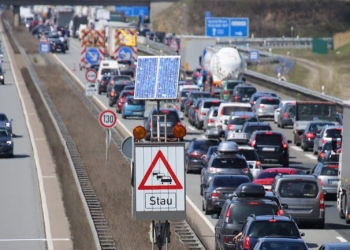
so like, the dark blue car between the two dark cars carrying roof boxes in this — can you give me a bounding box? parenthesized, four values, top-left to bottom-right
(202, 175, 251, 214)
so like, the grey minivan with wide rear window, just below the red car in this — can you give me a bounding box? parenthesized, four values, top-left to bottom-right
(271, 174, 325, 229)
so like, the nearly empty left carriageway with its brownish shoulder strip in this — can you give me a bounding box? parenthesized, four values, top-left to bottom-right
(0, 20, 73, 250)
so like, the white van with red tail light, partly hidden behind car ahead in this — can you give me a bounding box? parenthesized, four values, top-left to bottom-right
(215, 102, 252, 135)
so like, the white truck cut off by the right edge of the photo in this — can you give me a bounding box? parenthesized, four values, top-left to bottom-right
(332, 101, 350, 224)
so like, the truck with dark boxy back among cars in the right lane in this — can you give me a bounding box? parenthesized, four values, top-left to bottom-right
(293, 101, 337, 146)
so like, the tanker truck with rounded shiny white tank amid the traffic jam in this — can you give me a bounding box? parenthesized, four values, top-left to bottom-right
(201, 46, 246, 87)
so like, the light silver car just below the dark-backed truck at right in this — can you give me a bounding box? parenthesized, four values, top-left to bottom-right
(313, 125, 343, 154)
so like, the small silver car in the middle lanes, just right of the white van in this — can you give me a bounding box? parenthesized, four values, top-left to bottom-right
(253, 97, 281, 118)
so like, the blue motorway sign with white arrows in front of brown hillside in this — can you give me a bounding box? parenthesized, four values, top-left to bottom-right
(205, 17, 249, 38)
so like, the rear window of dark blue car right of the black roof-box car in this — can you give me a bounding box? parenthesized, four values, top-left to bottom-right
(248, 220, 300, 238)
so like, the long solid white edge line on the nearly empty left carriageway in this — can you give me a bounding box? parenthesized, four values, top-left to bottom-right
(1, 27, 54, 250)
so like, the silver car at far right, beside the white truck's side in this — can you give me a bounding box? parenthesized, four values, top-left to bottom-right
(310, 162, 339, 195)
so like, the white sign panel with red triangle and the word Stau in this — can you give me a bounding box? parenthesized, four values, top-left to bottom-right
(133, 142, 186, 220)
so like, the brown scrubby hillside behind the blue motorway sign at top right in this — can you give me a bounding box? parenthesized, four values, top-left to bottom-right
(152, 0, 350, 37)
